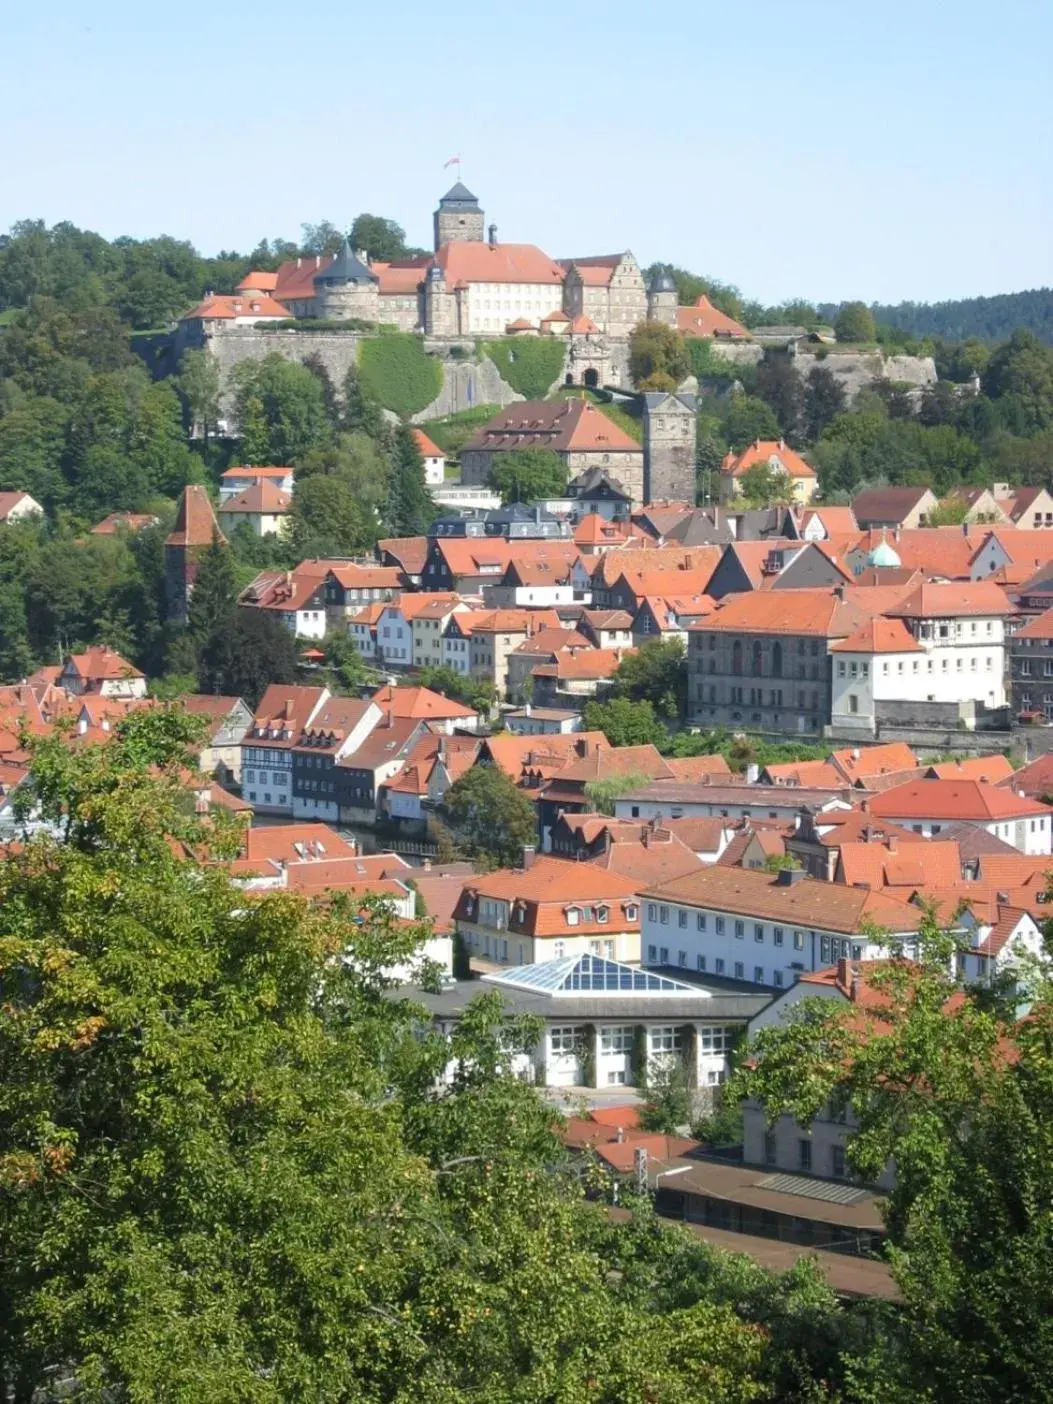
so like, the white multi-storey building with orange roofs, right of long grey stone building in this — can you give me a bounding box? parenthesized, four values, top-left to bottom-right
(830, 580, 1009, 736)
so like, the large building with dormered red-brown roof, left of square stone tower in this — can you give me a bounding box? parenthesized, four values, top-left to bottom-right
(461, 400, 643, 505)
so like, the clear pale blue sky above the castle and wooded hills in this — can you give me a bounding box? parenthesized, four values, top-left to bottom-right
(0, 0, 1053, 302)
